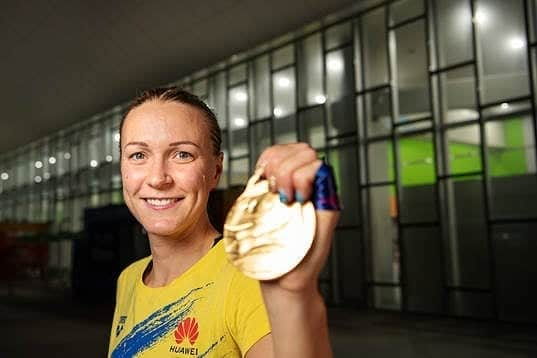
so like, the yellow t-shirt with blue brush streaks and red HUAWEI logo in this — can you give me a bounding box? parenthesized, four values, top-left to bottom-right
(108, 241, 270, 358)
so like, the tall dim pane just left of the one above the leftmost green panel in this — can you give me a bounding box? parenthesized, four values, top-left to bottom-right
(361, 7, 388, 88)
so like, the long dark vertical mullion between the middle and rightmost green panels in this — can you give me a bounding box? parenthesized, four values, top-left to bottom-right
(470, 0, 499, 319)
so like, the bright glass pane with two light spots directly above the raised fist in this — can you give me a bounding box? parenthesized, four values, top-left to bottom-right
(272, 68, 296, 118)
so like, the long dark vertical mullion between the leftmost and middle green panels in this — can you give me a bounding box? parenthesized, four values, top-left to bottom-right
(423, 0, 449, 312)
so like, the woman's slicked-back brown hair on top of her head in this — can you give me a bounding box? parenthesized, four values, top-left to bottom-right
(119, 86, 222, 155)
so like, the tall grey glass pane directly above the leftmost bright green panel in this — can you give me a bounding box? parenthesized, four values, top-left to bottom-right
(395, 21, 430, 121)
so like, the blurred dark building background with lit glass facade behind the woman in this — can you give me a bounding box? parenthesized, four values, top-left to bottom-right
(0, 0, 537, 357)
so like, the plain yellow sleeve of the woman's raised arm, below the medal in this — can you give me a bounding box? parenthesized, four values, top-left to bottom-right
(225, 271, 271, 356)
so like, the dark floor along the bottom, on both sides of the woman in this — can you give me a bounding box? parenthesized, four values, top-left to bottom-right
(0, 290, 537, 358)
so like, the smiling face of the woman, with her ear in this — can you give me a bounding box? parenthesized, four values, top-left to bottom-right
(121, 100, 222, 236)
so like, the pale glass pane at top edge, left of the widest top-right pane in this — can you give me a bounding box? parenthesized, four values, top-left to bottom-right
(434, 0, 473, 67)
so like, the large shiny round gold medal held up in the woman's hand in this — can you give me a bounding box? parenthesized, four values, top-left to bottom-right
(224, 168, 315, 280)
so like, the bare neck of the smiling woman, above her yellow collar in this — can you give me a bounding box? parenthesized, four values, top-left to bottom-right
(144, 215, 219, 287)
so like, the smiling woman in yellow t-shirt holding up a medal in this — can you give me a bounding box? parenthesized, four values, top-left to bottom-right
(109, 88, 338, 358)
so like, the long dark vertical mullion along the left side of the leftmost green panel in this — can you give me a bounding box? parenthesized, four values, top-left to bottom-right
(386, 2, 407, 312)
